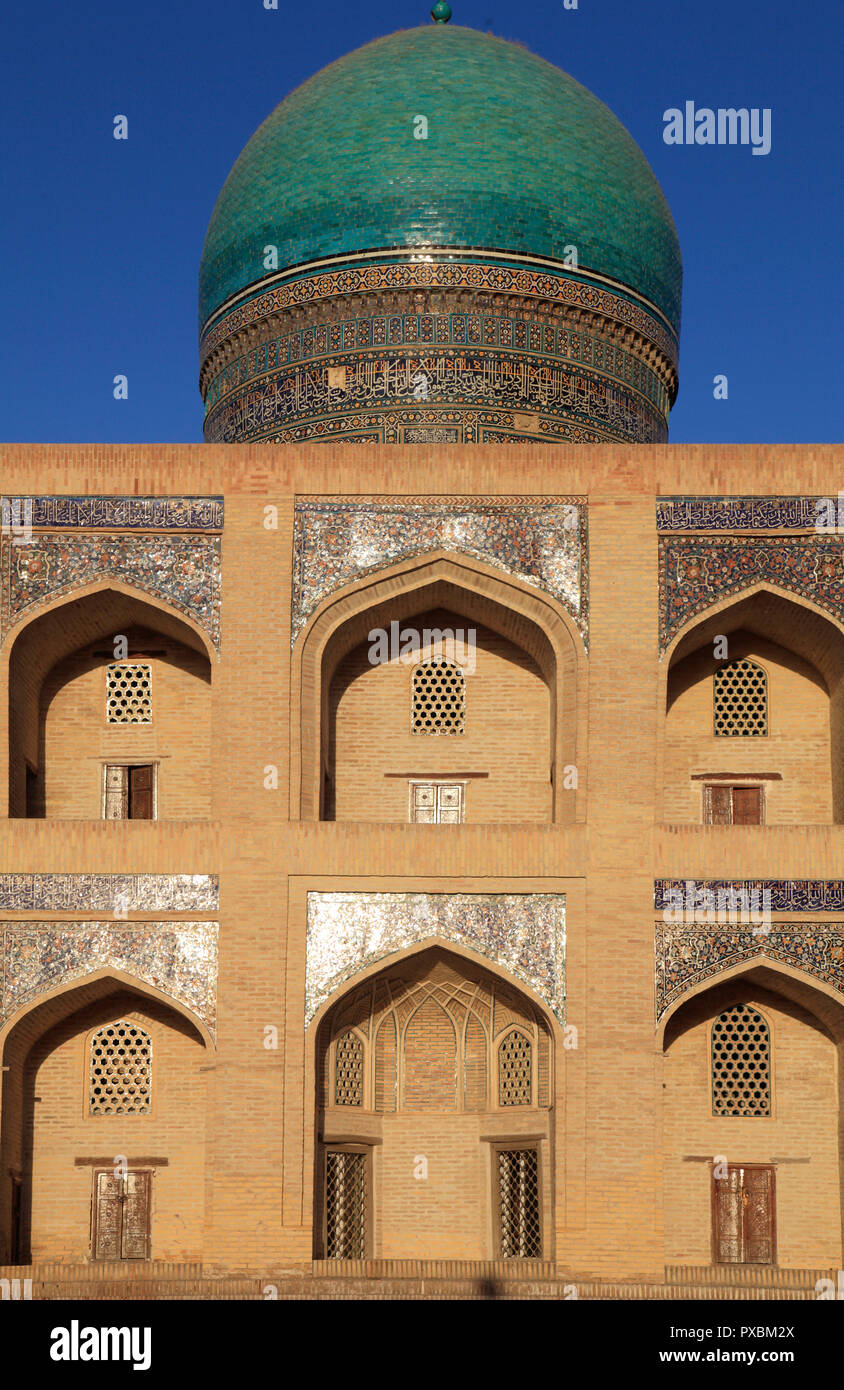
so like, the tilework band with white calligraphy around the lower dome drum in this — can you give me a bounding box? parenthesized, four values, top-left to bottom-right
(204, 350, 667, 443)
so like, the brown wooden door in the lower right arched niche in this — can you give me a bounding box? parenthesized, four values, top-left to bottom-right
(712, 1165, 776, 1265)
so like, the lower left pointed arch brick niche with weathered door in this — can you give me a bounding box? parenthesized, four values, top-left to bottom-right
(0, 970, 213, 1265)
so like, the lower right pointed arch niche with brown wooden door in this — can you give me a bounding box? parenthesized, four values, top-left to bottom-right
(658, 960, 844, 1269)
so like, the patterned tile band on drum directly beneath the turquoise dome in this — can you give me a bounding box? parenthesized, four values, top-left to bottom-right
(200, 247, 679, 364)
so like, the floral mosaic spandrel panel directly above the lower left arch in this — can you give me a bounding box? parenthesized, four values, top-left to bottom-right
(0, 922, 217, 1036)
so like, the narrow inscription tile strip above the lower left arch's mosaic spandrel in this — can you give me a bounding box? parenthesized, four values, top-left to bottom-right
(0, 873, 220, 912)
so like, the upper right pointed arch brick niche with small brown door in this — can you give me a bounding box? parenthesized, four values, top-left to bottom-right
(662, 587, 844, 824)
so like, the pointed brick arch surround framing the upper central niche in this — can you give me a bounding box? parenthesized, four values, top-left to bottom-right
(291, 550, 585, 820)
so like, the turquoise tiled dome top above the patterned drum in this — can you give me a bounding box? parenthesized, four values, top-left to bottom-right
(199, 24, 681, 331)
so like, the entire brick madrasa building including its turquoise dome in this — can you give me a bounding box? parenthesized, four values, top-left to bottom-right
(0, 0, 844, 1298)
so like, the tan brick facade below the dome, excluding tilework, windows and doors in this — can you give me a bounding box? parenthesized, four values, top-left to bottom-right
(0, 445, 844, 1290)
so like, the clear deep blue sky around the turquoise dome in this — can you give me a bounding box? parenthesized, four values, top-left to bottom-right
(0, 0, 844, 443)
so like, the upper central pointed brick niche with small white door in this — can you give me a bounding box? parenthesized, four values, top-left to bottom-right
(291, 552, 585, 821)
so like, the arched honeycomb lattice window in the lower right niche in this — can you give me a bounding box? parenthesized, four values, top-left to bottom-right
(712, 1004, 770, 1115)
